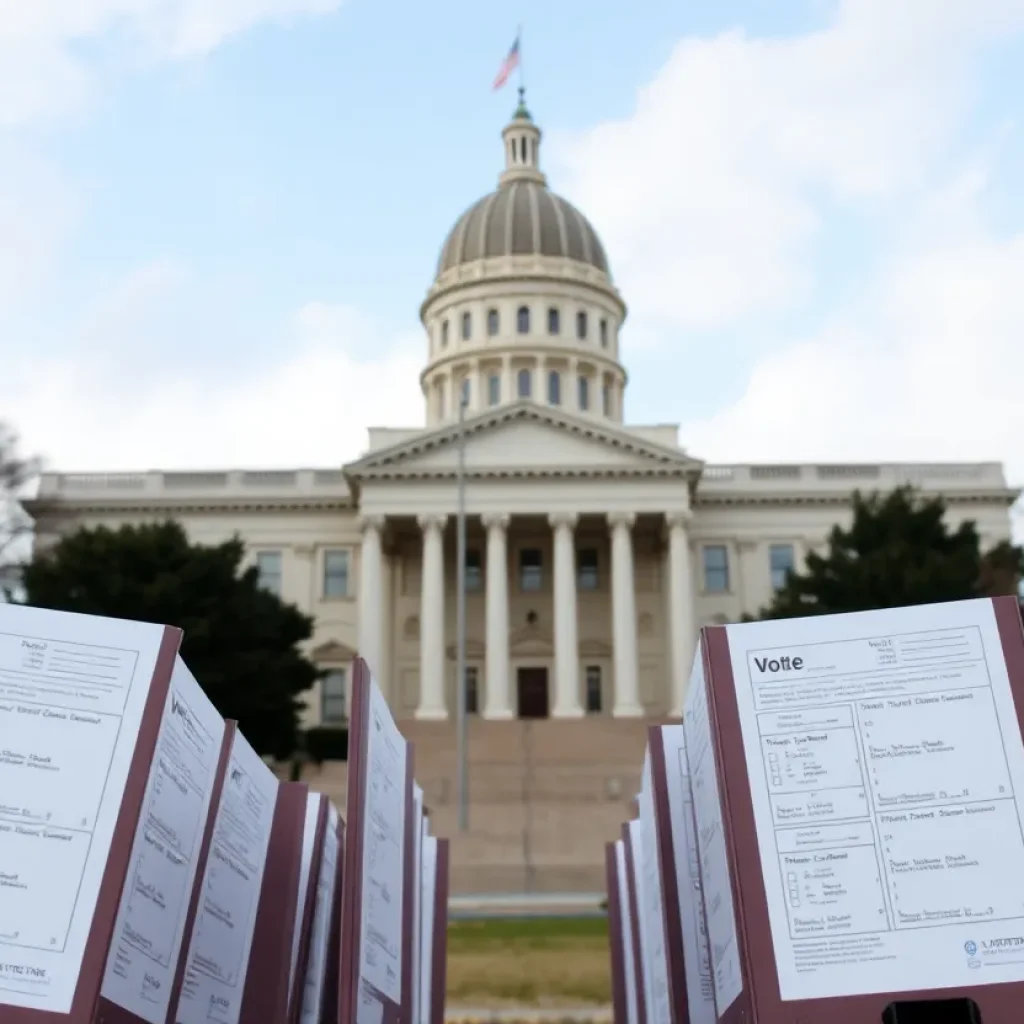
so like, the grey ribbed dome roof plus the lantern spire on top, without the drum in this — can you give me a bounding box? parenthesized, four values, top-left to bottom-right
(437, 89, 610, 276)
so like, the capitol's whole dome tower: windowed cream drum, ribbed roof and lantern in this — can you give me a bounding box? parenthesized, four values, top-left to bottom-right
(420, 88, 627, 427)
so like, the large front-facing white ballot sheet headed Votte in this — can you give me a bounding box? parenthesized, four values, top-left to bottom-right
(729, 600, 1024, 1011)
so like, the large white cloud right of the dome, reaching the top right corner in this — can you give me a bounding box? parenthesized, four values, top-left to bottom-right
(552, 0, 1024, 333)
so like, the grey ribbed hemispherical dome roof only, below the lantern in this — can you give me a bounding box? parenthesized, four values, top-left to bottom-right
(437, 179, 608, 274)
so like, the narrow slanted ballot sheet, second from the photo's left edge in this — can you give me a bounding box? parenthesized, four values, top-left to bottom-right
(101, 657, 224, 1024)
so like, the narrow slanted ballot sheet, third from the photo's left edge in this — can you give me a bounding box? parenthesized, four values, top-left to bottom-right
(177, 732, 279, 1024)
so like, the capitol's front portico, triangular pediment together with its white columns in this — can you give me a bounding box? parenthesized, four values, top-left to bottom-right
(346, 403, 699, 721)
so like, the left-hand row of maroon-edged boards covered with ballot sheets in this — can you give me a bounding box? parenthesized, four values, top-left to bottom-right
(0, 604, 449, 1024)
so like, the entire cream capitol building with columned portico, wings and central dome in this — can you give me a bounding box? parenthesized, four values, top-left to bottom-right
(29, 92, 1017, 725)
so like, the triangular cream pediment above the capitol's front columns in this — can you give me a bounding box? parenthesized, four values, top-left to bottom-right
(345, 401, 702, 480)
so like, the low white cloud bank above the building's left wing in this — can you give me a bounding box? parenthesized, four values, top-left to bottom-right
(0, 294, 423, 471)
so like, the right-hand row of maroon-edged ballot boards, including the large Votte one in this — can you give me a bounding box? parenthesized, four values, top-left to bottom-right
(608, 598, 1024, 1024)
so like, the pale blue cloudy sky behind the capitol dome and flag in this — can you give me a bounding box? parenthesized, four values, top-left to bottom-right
(0, 0, 1024, 528)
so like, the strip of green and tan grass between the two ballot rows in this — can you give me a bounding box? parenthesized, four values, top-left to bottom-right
(447, 918, 611, 1009)
